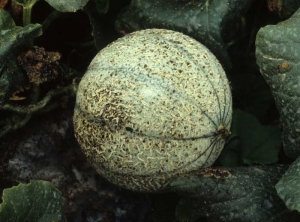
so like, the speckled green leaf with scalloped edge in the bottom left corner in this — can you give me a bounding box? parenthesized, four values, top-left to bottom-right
(0, 181, 64, 222)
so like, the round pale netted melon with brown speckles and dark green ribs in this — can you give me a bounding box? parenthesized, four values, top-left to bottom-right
(74, 29, 232, 192)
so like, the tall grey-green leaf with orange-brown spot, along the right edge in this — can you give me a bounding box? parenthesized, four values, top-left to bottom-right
(256, 7, 300, 158)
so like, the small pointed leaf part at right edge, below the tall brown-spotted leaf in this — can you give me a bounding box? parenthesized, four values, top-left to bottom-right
(275, 157, 300, 212)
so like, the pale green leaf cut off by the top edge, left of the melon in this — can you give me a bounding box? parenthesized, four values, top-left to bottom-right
(46, 0, 89, 12)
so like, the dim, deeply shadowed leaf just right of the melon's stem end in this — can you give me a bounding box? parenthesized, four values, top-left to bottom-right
(219, 109, 282, 166)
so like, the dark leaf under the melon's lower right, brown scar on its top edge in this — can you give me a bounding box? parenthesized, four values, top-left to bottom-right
(170, 166, 300, 222)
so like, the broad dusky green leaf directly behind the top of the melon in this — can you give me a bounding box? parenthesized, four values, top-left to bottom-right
(116, 0, 252, 67)
